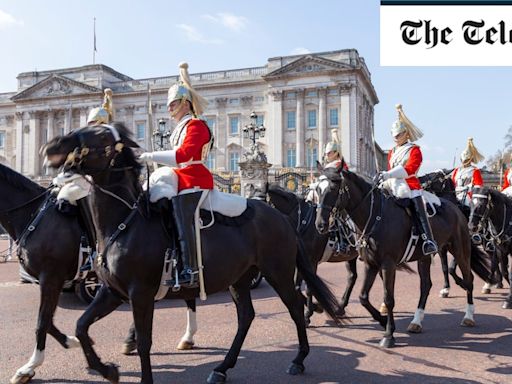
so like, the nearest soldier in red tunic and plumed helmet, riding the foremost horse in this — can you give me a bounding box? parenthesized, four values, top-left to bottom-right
(140, 63, 213, 288)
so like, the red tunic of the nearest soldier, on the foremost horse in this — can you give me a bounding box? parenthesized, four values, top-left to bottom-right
(173, 119, 213, 192)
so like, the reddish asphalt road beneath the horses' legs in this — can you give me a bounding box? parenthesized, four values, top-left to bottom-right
(0, 250, 512, 384)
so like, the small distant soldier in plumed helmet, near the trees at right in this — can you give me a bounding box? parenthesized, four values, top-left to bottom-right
(452, 137, 484, 212)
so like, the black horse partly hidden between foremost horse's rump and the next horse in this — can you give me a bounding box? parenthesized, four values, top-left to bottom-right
(267, 184, 358, 325)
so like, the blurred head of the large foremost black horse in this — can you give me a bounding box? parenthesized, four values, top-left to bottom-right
(42, 123, 140, 176)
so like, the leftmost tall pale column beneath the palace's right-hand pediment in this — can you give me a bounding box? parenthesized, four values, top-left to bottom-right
(267, 91, 284, 167)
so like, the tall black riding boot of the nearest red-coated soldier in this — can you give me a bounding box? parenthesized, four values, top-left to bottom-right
(171, 192, 202, 288)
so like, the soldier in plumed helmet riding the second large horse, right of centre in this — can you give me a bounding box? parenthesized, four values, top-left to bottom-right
(378, 104, 438, 255)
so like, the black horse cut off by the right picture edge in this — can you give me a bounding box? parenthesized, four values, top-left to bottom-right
(469, 187, 512, 309)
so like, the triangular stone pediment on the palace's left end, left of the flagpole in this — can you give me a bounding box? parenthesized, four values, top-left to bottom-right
(11, 74, 101, 101)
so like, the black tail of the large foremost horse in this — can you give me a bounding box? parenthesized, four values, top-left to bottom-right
(297, 238, 343, 324)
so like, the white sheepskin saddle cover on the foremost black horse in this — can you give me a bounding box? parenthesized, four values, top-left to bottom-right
(149, 167, 247, 217)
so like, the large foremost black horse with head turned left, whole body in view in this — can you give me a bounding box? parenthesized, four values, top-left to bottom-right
(45, 124, 339, 384)
